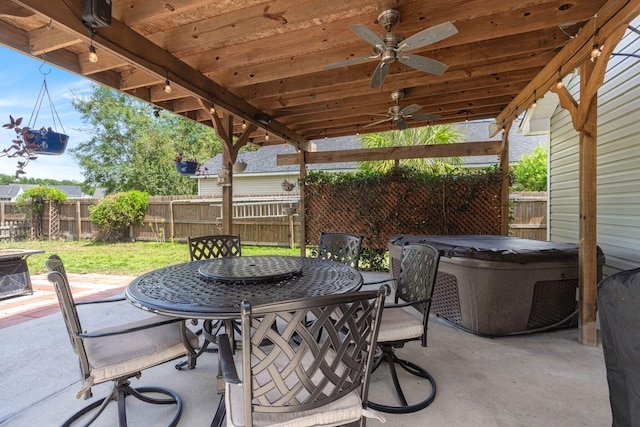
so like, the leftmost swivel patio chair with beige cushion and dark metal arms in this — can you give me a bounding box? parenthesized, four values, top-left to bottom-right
(45, 255, 198, 426)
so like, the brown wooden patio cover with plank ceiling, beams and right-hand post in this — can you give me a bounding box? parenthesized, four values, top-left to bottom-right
(0, 0, 640, 343)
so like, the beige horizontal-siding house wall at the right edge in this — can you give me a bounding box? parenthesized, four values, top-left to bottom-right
(527, 15, 640, 276)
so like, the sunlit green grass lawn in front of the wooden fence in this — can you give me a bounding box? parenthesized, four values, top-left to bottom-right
(0, 240, 300, 275)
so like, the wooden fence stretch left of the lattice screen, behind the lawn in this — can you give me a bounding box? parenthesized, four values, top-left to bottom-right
(0, 196, 300, 246)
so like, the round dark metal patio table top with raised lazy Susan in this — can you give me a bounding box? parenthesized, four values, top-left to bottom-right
(125, 256, 362, 320)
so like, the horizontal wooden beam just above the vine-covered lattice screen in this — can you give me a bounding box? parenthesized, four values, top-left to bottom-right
(278, 141, 502, 166)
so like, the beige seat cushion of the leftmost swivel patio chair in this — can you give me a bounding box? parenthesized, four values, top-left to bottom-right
(84, 316, 198, 384)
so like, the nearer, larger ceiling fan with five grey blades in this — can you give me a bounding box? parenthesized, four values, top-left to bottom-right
(323, 9, 458, 88)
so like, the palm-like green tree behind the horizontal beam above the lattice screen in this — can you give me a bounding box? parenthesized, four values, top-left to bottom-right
(359, 125, 462, 174)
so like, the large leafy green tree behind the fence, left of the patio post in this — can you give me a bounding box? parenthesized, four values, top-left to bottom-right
(70, 86, 222, 195)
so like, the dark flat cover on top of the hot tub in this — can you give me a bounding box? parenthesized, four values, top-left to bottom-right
(389, 234, 604, 264)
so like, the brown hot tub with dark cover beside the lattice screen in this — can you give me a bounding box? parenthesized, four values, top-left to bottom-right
(388, 234, 604, 336)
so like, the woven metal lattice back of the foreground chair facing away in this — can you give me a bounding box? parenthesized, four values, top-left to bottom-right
(242, 289, 385, 425)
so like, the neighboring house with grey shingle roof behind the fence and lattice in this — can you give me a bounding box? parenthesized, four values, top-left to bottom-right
(196, 122, 547, 200)
